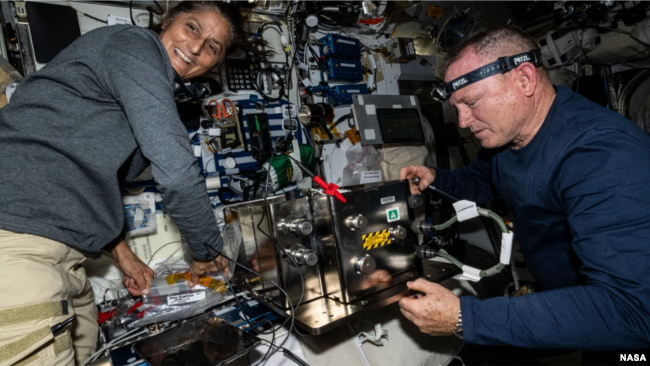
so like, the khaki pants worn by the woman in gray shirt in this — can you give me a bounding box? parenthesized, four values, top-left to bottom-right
(0, 230, 99, 366)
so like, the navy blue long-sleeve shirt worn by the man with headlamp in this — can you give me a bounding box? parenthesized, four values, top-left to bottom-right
(434, 87, 650, 351)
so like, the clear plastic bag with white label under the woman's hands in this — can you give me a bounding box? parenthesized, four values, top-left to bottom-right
(109, 272, 226, 338)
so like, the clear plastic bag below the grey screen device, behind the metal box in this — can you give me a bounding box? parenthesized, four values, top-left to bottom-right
(341, 144, 382, 187)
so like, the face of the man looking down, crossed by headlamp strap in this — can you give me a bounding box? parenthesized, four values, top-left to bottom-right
(445, 49, 531, 148)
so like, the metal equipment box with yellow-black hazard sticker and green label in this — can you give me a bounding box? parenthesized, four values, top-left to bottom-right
(312, 181, 421, 304)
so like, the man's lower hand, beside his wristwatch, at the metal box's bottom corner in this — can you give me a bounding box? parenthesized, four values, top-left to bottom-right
(399, 279, 460, 336)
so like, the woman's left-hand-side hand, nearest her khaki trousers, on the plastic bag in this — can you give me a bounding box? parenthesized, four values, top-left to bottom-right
(110, 238, 154, 296)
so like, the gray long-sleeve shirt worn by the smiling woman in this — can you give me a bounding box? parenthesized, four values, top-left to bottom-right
(0, 26, 222, 259)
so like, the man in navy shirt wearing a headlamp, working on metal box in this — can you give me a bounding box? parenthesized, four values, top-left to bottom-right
(400, 27, 650, 364)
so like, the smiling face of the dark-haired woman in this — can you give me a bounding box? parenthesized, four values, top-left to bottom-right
(160, 11, 230, 79)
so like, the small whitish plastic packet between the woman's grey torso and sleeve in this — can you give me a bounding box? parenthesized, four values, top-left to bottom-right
(122, 192, 156, 236)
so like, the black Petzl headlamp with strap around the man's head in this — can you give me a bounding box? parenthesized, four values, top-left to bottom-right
(431, 49, 542, 103)
